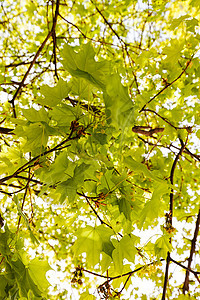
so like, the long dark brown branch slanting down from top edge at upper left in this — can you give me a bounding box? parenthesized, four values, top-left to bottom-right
(9, 0, 60, 118)
